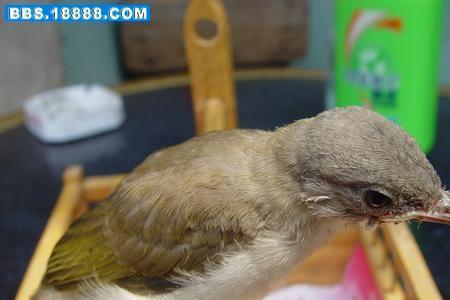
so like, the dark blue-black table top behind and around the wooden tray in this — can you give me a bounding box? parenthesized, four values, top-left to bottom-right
(0, 79, 450, 299)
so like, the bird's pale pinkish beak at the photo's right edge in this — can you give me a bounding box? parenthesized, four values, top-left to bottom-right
(382, 191, 450, 225)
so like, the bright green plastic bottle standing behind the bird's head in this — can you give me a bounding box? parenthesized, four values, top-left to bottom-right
(334, 0, 443, 152)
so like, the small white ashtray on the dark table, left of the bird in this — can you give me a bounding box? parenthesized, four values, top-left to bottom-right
(23, 84, 125, 143)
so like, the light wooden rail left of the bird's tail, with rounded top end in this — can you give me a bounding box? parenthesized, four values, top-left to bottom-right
(15, 166, 83, 300)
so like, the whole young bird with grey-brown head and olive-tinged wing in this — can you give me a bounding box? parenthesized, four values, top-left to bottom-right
(34, 107, 450, 300)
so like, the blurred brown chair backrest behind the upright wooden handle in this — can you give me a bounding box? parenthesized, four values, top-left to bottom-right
(118, 0, 310, 76)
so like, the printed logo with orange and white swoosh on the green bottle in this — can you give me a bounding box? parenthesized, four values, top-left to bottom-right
(345, 10, 403, 121)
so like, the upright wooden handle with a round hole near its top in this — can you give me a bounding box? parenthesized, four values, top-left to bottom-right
(184, 0, 237, 134)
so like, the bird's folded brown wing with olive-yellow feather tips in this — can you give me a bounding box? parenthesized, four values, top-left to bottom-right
(45, 132, 260, 289)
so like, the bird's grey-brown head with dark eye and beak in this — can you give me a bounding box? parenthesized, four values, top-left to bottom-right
(281, 107, 450, 224)
